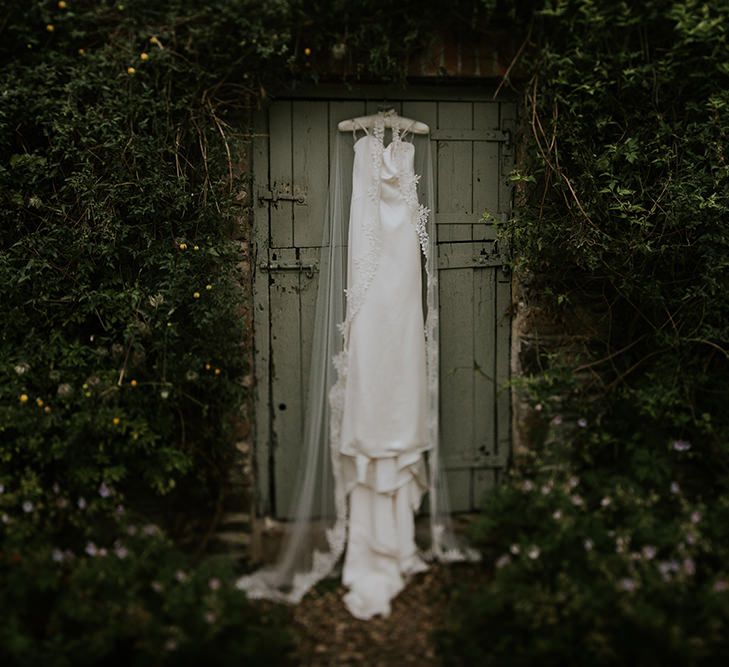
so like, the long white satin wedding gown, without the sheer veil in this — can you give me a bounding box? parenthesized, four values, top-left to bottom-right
(339, 121, 428, 619)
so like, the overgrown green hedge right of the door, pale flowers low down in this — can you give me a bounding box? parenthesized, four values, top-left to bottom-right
(440, 0, 729, 665)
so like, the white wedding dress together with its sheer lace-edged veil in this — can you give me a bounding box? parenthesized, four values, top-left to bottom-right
(237, 111, 478, 619)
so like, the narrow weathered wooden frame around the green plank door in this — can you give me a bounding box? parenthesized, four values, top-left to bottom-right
(251, 79, 517, 517)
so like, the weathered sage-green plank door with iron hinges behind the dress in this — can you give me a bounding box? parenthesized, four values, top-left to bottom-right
(253, 86, 515, 518)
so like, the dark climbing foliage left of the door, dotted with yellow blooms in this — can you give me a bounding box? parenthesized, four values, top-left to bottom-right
(0, 0, 500, 665)
